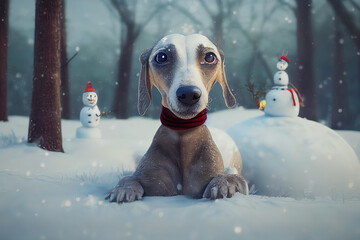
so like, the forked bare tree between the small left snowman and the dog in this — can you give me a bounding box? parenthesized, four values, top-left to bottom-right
(111, 0, 161, 119)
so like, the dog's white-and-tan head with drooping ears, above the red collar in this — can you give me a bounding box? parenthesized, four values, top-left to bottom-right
(138, 34, 236, 119)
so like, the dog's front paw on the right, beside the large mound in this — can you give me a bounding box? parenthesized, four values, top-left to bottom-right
(203, 174, 248, 200)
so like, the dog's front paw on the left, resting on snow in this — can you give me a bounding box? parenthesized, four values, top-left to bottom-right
(105, 177, 144, 203)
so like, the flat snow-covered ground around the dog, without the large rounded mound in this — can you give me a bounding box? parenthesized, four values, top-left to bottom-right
(0, 108, 360, 239)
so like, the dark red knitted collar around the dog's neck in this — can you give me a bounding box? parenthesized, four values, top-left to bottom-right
(160, 106, 207, 130)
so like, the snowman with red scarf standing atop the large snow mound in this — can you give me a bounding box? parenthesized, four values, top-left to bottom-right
(264, 54, 302, 117)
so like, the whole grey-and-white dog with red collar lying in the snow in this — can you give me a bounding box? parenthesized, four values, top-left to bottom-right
(106, 34, 248, 203)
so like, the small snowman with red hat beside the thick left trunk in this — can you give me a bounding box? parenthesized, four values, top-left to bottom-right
(76, 82, 101, 138)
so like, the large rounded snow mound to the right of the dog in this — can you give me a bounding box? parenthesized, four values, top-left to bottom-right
(228, 116, 360, 198)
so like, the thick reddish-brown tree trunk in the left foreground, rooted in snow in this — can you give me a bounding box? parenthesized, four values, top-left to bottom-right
(28, 0, 64, 152)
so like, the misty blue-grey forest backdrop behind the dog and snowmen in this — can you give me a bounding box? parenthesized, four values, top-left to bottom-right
(2, 0, 360, 130)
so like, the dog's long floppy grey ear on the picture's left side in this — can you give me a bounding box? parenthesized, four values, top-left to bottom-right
(138, 49, 153, 115)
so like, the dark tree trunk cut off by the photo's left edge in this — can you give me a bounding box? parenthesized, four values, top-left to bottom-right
(0, 0, 9, 121)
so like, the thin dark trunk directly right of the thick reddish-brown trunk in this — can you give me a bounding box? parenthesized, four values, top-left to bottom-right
(60, 0, 71, 119)
